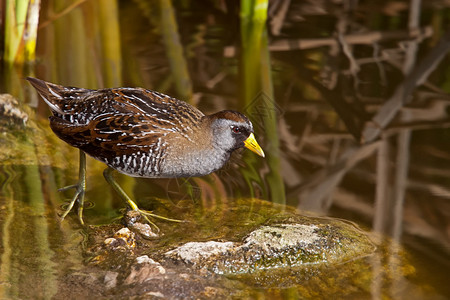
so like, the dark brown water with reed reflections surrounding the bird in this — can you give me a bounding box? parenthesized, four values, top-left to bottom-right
(0, 1, 450, 298)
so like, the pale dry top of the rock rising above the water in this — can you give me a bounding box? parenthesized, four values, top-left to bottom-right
(165, 222, 374, 274)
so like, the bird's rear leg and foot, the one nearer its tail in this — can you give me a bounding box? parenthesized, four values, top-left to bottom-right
(58, 150, 86, 225)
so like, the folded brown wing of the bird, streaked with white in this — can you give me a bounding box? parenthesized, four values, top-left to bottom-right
(50, 89, 203, 161)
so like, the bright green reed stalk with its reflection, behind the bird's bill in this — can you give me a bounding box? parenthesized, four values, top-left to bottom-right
(240, 0, 285, 203)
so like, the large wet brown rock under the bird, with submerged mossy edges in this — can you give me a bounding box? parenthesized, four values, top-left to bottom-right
(57, 199, 375, 299)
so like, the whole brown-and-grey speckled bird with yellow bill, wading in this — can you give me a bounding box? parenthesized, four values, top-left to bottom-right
(27, 77, 264, 224)
